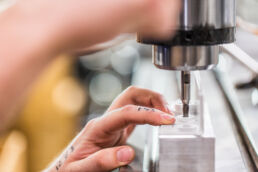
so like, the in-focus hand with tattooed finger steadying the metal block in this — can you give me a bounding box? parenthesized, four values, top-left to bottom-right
(46, 87, 175, 172)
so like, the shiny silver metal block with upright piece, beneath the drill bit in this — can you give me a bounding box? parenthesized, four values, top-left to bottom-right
(143, 72, 215, 172)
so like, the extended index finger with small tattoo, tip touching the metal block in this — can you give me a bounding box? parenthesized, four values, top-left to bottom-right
(96, 105, 175, 133)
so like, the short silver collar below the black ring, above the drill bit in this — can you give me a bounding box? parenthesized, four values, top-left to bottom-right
(152, 45, 219, 71)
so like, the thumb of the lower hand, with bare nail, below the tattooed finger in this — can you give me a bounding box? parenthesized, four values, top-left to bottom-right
(67, 146, 135, 172)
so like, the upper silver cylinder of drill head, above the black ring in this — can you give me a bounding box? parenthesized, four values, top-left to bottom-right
(177, 0, 236, 30)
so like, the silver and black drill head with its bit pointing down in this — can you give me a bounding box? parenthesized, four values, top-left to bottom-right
(138, 0, 236, 117)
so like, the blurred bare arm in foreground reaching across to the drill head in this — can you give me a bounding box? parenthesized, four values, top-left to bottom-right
(0, 0, 179, 131)
